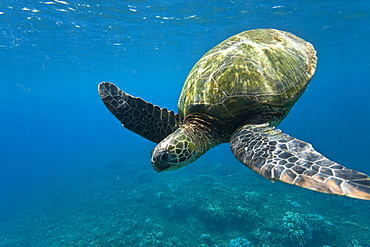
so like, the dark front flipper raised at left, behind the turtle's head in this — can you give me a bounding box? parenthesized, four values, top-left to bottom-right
(98, 82, 179, 143)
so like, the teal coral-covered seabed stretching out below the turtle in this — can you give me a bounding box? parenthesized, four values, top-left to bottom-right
(0, 159, 370, 247)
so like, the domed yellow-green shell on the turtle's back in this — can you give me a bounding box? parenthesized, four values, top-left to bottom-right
(178, 29, 317, 121)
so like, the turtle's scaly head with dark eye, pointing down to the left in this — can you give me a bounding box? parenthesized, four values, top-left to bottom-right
(152, 128, 199, 172)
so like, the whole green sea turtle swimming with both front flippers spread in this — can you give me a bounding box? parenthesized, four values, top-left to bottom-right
(98, 29, 370, 200)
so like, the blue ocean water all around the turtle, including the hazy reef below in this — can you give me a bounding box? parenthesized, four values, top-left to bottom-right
(0, 0, 370, 246)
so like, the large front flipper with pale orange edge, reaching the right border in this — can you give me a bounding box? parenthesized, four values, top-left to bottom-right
(230, 124, 370, 200)
